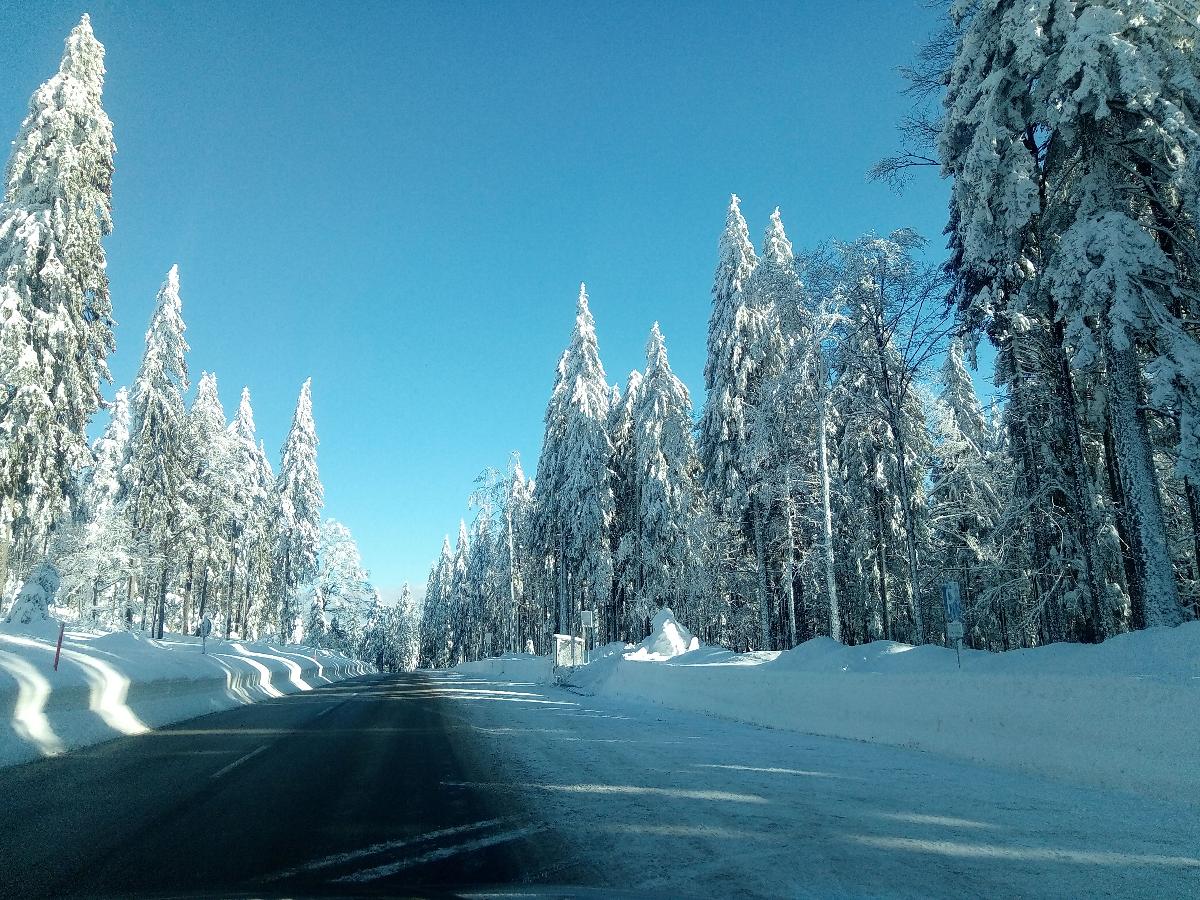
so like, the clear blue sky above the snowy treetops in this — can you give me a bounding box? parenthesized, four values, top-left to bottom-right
(0, 0, 948, 600)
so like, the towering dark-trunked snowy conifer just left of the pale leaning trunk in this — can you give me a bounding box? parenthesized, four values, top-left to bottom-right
(937, 0, 1140, 641)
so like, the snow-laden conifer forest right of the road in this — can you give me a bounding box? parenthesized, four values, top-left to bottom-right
(420, 0, 1200, 666)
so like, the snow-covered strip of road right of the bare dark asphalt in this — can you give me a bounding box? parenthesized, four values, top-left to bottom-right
(431, 673, 1200, 898)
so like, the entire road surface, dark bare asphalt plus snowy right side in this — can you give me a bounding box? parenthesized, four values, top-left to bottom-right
(0, 672, 1200, 899)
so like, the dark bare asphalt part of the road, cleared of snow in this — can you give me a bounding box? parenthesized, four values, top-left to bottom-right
(0, 674, 578, 898)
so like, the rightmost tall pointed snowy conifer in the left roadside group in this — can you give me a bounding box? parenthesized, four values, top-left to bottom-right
(275, 378, 324, 640)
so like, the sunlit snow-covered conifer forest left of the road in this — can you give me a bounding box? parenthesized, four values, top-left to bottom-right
(0, 16, 415, 668)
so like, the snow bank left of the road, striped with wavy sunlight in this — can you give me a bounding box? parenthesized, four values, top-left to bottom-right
(0, 624, 370, 766)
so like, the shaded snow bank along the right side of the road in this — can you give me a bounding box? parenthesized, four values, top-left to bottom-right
(571, 622, 1200, 803)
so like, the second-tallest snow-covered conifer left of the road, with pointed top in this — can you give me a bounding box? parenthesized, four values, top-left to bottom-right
(124, 265, 187, 637)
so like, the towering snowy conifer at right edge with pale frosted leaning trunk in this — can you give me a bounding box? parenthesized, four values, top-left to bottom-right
(1043, 0, 1200, 636)
